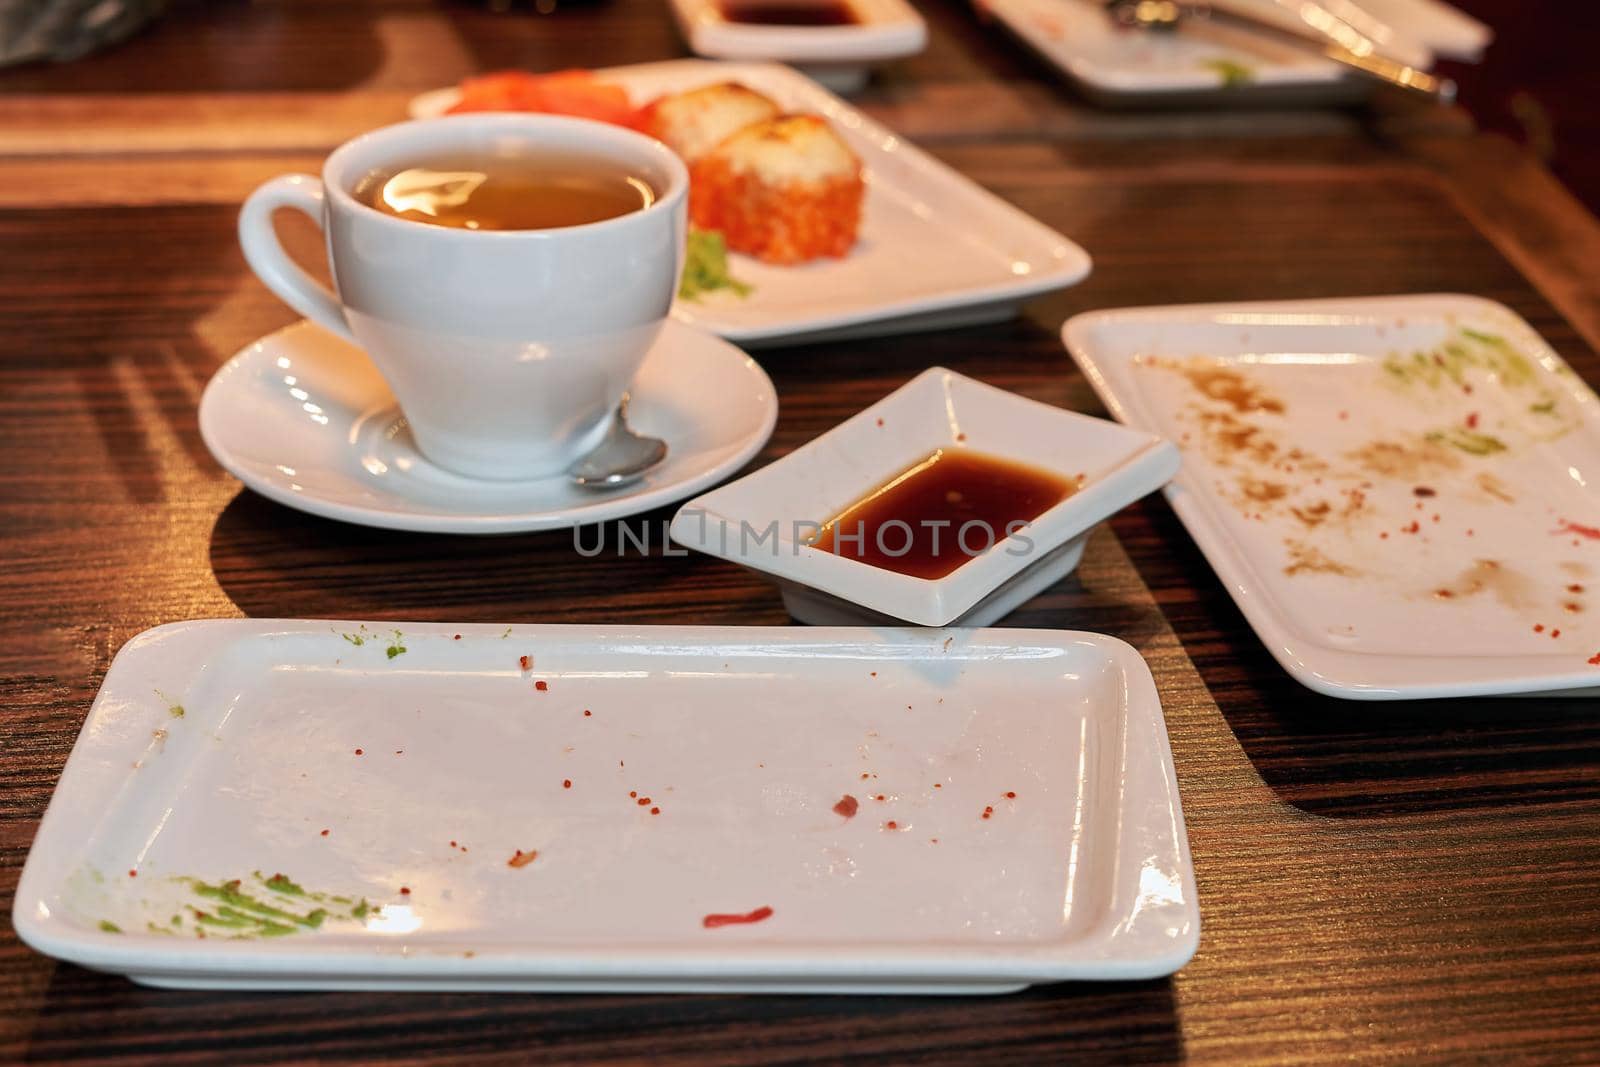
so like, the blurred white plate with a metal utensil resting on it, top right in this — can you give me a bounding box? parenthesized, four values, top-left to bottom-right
(976, 0, 1488, 102)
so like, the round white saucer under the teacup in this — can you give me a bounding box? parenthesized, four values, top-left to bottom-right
(200, 322, 778, 534)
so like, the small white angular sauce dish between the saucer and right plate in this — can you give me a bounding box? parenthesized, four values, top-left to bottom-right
(672, 366, 1179, 625)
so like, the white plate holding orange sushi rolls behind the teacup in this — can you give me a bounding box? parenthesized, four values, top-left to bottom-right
(411, 59, 1090, 347)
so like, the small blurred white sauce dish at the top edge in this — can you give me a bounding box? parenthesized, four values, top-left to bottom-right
(670, 0, 928, 93)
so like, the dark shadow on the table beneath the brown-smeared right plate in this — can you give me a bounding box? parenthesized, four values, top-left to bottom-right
(1117, 498, 1600, 819)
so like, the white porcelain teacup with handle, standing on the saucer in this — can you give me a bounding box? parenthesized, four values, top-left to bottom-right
(238, 114, 688, 478)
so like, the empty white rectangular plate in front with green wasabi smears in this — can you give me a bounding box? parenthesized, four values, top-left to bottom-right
(13, 619, 1198, 993)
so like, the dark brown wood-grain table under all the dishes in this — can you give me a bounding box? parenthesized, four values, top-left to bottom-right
(0, 0, 1600, 1064)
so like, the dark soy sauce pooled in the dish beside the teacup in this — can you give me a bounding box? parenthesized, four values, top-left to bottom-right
(810, 448, 1078, 577)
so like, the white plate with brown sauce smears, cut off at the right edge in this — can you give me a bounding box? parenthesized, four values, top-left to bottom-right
(1062, 294, 1600, 701)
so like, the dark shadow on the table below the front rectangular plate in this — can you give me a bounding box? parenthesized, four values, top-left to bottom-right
(22, 965, 1182, 1067)
